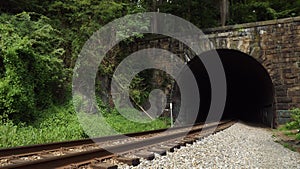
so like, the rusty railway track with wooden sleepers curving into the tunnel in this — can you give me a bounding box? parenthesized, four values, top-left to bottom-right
(0, 121, 234, 169)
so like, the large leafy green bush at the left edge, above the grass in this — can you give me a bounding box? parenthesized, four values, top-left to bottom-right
(0, 12, 65, 121)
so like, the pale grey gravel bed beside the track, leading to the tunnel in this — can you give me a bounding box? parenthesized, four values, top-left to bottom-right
(119, 123, 300, 169)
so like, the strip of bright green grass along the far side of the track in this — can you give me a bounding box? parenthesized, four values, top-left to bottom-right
(0, 103, 170, 148)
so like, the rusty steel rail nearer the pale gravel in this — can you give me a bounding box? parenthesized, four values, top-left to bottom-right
(0, 121, 234, 169)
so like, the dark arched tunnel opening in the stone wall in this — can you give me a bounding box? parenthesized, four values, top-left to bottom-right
(179, 49, 274, 127)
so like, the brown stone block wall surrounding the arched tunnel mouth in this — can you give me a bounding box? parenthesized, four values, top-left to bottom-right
(131, 17, 300, 125)
